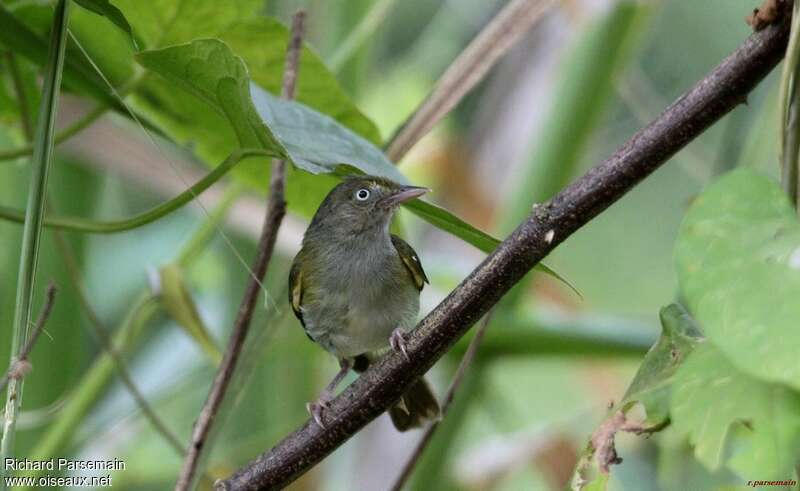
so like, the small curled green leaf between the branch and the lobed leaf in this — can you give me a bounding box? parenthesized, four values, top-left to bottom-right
(622, 304, 702, 424)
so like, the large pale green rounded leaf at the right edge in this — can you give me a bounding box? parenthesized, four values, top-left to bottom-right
(675, 169, 800, 388)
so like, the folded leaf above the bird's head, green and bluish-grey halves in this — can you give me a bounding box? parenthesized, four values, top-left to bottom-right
(137, 39, 406, 223)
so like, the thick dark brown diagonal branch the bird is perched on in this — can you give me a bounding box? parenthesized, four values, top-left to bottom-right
(217, 13, 789, 490)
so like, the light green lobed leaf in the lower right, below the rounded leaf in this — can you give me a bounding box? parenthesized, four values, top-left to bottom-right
(670, 342, 800, 479)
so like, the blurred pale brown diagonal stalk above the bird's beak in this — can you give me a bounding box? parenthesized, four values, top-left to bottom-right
(386, 0, 556, 162)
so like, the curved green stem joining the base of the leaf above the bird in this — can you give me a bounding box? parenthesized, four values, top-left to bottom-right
(0, 149, 273, 234)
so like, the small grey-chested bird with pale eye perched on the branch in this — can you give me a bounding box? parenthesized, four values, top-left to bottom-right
(289, 176, 439, 431)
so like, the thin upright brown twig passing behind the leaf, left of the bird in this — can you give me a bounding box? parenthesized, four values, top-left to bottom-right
(175, 10, 305, 491)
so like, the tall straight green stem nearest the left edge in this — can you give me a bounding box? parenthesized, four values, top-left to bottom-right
(0, 0, 71, 476)
